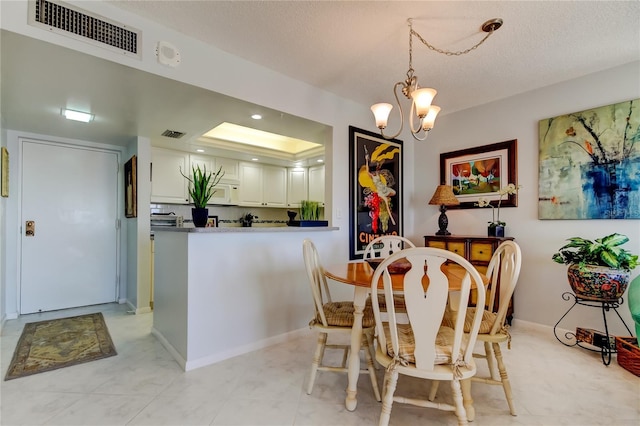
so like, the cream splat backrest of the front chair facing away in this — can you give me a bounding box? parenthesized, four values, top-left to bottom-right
(371, 247, 485, 371)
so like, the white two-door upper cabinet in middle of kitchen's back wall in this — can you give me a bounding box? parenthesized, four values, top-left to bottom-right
(238, 162, 287, 207)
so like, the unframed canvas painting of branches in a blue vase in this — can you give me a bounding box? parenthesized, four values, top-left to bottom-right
(538, 99, 640, 219)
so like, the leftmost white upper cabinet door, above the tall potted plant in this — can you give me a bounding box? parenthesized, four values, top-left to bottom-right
(151, 148, 190, 204)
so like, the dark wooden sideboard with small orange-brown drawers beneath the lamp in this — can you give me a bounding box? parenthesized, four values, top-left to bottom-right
(424, 235, 513, 324)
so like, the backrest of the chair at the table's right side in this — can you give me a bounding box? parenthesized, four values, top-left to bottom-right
(478, 241, 522, 334)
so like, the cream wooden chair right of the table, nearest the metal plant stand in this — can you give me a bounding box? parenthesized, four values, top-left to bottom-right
(438, 241, 522, 416)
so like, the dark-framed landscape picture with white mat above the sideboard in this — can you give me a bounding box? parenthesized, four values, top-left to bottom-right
(440, 139, 518, 209)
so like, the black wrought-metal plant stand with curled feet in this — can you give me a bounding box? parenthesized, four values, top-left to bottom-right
(553, 291, 633, 365)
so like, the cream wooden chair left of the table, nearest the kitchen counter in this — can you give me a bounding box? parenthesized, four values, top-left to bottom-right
(302, 239, 381, 401)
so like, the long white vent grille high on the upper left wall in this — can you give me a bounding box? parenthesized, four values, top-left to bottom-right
(29, 0, 142, 59)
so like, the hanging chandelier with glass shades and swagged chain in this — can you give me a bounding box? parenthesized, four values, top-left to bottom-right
(371, 18, 502, 141)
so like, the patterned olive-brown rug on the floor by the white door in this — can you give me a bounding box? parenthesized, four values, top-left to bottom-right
(4, 312, 117, 380)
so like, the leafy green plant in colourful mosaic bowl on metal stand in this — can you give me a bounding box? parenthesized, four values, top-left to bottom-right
(552, 233, 638, 301)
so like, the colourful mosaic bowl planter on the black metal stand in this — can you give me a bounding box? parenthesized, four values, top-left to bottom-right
(567, 264, 631, 301)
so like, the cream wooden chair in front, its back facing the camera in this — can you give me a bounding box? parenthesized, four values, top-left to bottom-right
(371, 247, 485, 425)
